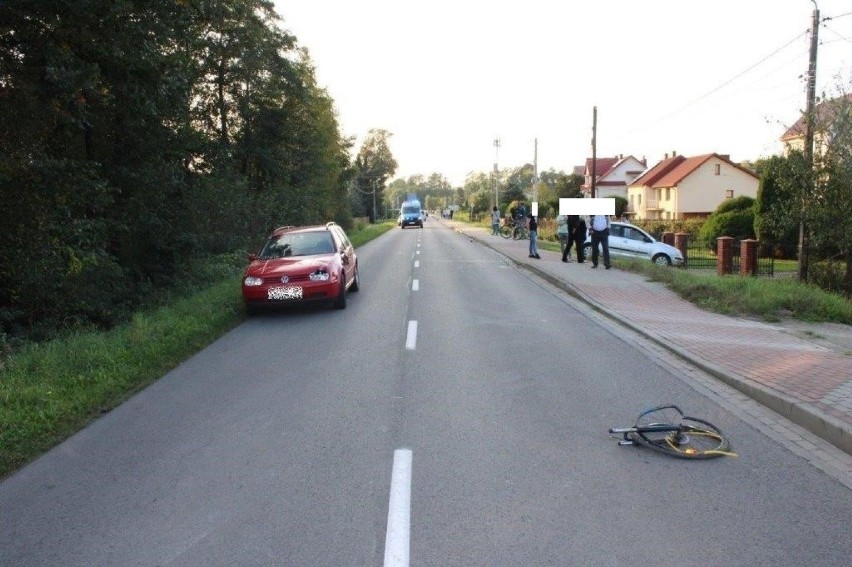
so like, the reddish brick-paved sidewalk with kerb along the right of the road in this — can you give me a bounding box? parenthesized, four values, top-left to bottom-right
(443, 221, 852, 455)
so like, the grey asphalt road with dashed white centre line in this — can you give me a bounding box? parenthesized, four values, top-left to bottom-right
(0, 221, 852, 566)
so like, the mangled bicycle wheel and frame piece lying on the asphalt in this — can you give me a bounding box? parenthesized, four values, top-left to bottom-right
(609, 406, 737, 459)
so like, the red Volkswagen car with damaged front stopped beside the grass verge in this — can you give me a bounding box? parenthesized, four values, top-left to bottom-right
(243, 222, 359, 312)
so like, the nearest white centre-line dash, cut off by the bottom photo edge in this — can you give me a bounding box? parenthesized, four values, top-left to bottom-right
(384, 449, 411, 567)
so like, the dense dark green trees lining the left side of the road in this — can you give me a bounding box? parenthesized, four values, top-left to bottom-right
(0, 0, 353, 340)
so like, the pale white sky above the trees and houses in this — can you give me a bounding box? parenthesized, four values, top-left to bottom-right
(275, 0, 852, 186)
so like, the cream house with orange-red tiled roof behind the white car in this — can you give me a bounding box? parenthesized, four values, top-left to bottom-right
(627, 153, 760, 219)
